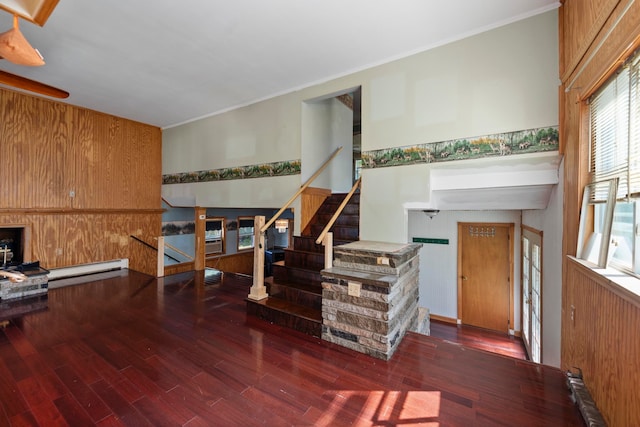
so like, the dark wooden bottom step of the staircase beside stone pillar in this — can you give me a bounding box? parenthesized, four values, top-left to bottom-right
(246, 297, 322, 338)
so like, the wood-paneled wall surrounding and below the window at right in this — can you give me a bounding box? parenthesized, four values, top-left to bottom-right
(559, 0, 640, 426)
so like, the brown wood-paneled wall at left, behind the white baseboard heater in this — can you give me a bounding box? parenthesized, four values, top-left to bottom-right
(0, 89, 162, 276)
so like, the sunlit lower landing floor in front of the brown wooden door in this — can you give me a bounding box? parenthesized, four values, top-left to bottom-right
(430, 320, 529, 360)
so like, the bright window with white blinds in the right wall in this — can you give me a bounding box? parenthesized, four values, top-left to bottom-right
(589, 48, 640, 274)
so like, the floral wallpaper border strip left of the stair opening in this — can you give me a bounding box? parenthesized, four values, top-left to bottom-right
(162, 160, 300, 184)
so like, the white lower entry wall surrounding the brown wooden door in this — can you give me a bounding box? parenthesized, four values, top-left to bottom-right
(406, 210, 521, 331)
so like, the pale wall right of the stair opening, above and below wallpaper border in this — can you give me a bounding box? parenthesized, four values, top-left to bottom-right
(360, 11, 558, 243)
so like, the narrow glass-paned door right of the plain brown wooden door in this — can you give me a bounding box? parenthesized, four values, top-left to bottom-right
(522, 228, 542, 363)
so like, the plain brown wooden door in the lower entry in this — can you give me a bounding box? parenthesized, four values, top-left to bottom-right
(458, 223, 514, 333)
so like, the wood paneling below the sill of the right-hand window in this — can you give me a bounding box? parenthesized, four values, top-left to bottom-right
(562, 260, 640, 426)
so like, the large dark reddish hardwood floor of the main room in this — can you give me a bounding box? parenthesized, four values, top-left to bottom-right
(0, 271, 583, 426)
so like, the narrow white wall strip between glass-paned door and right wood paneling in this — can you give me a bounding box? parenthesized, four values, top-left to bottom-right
(522, 158, 564, 367)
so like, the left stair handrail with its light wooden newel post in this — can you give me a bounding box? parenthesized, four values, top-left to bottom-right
(248, 147, 342, 301)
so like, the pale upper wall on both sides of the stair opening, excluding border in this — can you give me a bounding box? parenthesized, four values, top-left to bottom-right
(162, 11, 558, 217)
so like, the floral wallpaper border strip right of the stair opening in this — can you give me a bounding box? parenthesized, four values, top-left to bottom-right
(362, 126, 559, 169)
